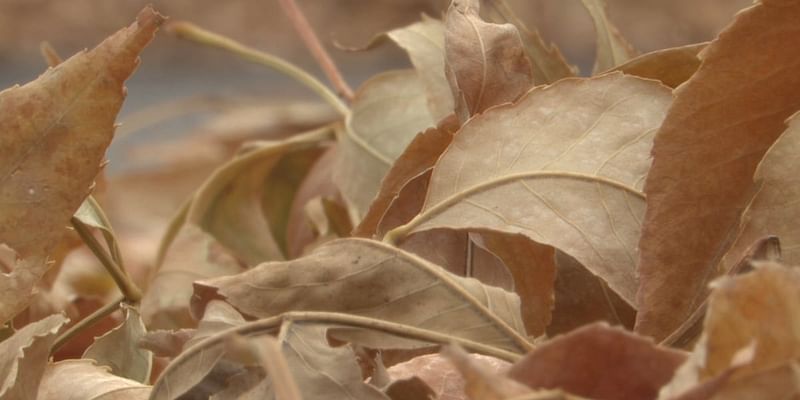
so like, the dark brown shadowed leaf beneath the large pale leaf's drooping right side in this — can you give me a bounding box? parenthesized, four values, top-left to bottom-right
(547, 251, 636, 336)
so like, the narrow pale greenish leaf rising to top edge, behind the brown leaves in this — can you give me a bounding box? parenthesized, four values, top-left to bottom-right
(581, 0, 637, 74)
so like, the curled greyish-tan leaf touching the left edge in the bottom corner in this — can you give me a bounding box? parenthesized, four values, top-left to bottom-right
(0, 314, 67, 400)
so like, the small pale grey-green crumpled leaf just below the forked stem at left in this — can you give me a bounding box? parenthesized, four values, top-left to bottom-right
(82, 304, 153, 384)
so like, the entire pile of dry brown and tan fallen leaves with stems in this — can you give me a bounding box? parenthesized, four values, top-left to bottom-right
(0, 0, 800, 400)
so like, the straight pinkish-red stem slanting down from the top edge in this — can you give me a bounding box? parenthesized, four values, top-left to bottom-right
(280, 0, 353, 100)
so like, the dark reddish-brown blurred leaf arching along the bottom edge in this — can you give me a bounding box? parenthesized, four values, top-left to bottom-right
(508, 323, 686, 399)
